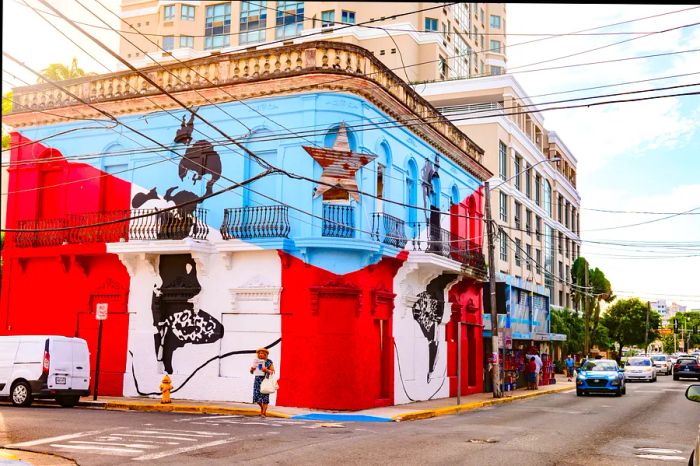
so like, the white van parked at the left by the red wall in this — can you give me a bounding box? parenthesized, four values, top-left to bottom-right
(0, 335, 90, 407)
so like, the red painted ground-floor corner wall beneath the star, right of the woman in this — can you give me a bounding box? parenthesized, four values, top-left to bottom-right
(277, 251, 403, 410)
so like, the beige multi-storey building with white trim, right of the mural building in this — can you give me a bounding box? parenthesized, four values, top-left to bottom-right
(421, 75, 581, 307)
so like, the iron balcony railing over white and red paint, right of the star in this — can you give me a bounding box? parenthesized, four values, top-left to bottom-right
(409, 223, 486, 271)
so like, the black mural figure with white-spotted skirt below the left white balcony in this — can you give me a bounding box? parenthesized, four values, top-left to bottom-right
(151, 254, 224, 374)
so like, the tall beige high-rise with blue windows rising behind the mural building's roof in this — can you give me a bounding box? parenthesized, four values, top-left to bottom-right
(120, 0, 506, 82)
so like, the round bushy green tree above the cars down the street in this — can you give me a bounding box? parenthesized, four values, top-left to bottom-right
(601, 298, 661, 358)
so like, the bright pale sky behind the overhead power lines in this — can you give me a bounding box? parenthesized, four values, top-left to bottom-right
(2, 0, 700, 309)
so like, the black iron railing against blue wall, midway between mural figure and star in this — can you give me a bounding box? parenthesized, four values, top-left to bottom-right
(220, 205, 291, 239)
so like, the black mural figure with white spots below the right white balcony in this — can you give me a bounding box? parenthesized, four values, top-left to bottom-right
(413, 274, 457, 383)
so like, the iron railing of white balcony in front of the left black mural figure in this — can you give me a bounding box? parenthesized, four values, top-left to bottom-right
(129, 207, 209, 240)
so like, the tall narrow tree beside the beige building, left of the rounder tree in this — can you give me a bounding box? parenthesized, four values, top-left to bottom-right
(571, 257, 615, 354)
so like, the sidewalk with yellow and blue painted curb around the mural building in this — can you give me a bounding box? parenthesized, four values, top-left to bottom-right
(74, 374, 575, 422)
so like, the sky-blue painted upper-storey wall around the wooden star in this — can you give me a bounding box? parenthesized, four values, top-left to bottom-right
(22, 93, 480, 273)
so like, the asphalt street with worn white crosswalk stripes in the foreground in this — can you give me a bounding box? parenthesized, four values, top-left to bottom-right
(0, 376, 700, 466)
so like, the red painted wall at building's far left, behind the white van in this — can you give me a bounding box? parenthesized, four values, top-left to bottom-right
(0, 133, 131, 395)
